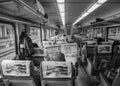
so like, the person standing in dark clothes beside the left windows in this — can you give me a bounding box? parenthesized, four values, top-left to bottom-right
(19, 31, 34, 60)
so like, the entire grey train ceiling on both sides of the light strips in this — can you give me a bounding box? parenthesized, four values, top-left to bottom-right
(0, 0, 120, 26)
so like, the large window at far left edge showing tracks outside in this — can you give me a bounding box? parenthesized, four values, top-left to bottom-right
(0, 24, 15, 62)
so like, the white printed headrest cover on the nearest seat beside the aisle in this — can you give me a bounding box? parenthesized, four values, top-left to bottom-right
(41, 61, 72, 79)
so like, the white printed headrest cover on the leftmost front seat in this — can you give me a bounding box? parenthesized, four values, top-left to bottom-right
(1, 60, 30, 76)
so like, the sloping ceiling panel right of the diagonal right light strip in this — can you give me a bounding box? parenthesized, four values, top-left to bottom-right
(78, 0, 120, 24)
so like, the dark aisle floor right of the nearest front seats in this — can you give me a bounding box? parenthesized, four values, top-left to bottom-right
(75, 67, 97, 86)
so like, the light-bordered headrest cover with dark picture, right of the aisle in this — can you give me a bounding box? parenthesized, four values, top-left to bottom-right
(98, 45, 112, 53)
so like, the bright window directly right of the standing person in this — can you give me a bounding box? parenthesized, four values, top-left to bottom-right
(30, 27, 41, 46)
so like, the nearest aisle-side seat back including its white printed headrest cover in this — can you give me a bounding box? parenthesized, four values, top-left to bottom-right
(41, 61, 73, 86)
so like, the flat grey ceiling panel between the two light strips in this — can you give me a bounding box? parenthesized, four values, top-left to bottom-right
(66, 0, 96, 24)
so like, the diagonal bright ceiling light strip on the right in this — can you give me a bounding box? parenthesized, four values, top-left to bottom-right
(73, 0, 107, 25)
